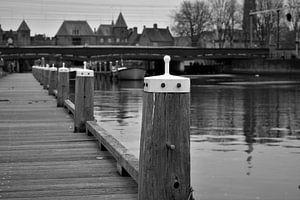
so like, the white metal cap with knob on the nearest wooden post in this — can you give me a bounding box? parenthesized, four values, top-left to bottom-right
(144, 55, 190, 93)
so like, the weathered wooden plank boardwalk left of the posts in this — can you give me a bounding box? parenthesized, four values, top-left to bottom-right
(0, 74, 137, 200)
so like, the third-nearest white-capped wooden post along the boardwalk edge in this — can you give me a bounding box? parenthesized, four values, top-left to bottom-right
(57, 63, 69, 107)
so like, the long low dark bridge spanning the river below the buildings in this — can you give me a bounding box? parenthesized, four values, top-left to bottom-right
(0, 46, 269, 61)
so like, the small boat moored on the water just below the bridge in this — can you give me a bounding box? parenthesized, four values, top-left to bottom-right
(112, 67, 146, 80)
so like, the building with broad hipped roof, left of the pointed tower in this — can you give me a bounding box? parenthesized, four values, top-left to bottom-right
(55, 20, 96, 46)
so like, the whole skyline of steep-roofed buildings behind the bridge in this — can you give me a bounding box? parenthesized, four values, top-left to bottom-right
(0, 12, 174, 47)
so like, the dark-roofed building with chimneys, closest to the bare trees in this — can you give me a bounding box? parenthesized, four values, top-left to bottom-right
(138, 24, 174, 46)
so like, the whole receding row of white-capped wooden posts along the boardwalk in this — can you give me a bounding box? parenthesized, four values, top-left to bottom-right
(33, 56, 193, 200)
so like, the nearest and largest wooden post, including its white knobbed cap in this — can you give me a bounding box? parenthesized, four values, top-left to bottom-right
(138, 56, 191, 200)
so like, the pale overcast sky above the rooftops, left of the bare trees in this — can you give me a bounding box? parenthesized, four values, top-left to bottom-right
(0, 0, 183, 37)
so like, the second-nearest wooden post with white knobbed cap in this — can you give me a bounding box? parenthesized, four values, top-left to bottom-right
(74, 62, 94, 132)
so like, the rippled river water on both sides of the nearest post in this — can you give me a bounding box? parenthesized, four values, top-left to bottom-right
(95, 75, 300, 200)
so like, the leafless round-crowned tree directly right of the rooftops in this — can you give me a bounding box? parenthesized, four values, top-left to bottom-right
(172, 0, 211, 46)
